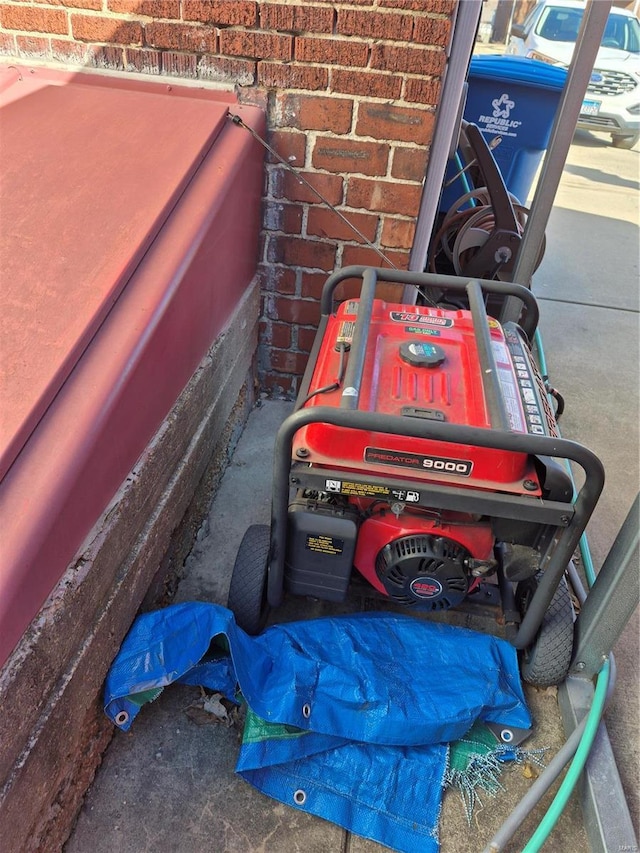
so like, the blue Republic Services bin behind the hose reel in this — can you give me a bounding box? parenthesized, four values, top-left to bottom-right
(440, 56, 567, 210)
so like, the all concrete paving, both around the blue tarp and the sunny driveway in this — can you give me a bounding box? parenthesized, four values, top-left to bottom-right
(65, 135, 640, 853)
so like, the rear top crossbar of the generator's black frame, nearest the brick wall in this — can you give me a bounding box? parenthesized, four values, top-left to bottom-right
(320, 266, 540, 340)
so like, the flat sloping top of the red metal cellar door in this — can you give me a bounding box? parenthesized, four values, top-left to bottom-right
(0, 66, 235, 478)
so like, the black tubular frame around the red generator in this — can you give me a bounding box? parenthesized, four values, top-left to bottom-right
(266, 266, 604, 649)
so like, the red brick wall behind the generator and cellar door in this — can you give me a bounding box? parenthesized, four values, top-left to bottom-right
(0, 0, 456, 396)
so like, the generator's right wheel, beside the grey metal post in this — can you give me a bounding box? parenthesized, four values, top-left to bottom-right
(516, 572, 574, 687)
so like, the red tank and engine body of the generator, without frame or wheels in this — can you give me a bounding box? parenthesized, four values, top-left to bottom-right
(284, 290, 571, 611)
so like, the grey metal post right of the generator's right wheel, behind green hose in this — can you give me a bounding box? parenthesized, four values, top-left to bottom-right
(571, 494, 640, 678)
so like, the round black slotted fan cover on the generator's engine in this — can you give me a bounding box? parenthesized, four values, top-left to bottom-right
(376, 535, 469, 610)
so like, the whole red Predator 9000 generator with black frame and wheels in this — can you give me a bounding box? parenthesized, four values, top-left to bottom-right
(229, 267, 604, 685)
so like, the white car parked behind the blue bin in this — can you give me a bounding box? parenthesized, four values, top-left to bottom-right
(506, 0, 640, 148)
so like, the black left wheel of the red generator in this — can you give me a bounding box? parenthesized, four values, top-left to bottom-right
(227, 524, 271, 634)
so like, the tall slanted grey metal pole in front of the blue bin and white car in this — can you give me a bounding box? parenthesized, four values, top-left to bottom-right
(501, 0, 611, 323)
